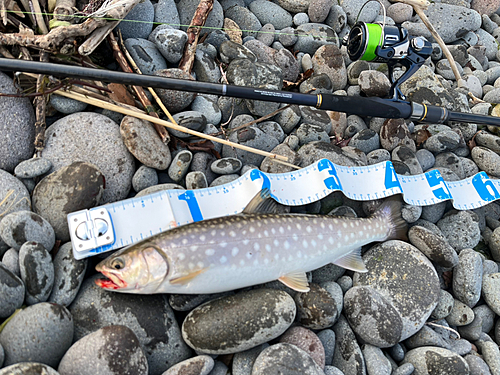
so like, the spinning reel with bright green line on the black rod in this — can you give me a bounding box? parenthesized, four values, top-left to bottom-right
(343, 8, 432, 101)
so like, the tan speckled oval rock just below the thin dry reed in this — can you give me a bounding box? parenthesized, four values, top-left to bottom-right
(120, 116, 172, 170)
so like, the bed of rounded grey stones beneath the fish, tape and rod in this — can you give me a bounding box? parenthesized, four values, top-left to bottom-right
(0, 0, 500, 375)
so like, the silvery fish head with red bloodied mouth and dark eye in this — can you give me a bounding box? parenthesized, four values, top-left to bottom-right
(95, 242, 169, 294)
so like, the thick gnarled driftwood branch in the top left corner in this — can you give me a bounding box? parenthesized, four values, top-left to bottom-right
(0, 0, 140, 52)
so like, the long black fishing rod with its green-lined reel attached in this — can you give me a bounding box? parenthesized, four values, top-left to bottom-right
(0, 22, 500, 126)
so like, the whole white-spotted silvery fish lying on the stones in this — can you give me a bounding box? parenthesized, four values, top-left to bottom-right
(95, 189, 407, 294)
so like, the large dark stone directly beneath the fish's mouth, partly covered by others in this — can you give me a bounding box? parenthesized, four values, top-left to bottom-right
(70, 275, 191, 375)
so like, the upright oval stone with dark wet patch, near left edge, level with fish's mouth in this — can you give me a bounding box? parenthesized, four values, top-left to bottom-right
(19, 242, 54, 305)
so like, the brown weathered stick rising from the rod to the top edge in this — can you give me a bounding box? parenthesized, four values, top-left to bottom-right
(179, 0, 214, 73)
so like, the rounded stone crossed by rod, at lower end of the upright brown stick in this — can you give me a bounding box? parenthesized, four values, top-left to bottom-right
(154, 69, 196, 113)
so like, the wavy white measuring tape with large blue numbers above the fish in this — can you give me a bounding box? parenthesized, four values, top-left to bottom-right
(68, 159, 500, 259)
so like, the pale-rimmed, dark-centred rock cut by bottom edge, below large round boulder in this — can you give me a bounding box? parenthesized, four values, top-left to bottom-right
(403, 346, 469, 375)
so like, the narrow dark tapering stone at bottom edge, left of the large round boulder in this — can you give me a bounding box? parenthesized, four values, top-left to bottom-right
(332, 315, 365, 374)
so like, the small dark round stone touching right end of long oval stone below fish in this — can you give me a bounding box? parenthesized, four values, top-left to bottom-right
(295, 283, 339, 329)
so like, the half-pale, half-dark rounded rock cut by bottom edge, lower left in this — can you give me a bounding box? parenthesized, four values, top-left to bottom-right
(58, 325, 148, 375)
